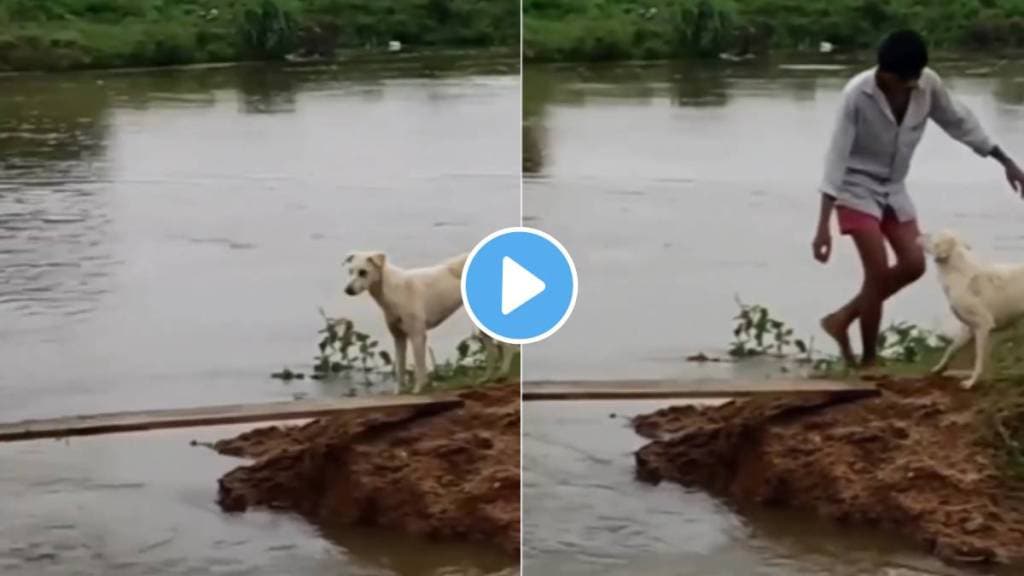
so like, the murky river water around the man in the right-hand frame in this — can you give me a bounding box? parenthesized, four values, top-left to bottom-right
(523, 60, 1024, 576)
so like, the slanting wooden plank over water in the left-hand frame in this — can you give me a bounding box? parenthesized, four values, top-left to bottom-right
(0, 395, 463, 442)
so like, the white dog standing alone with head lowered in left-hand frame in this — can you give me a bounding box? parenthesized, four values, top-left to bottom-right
(344, 252, 514, 393)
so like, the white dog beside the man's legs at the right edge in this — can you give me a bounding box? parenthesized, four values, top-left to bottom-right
(919, 232, 1024, 388)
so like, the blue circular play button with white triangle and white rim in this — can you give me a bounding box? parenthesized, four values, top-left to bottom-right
(462, 228, 579, 344)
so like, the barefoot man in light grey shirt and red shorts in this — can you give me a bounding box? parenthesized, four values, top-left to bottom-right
(813, 30, 1024, 367)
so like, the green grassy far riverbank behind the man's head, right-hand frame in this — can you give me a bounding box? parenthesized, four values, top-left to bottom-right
(523, 0, 1024, 61)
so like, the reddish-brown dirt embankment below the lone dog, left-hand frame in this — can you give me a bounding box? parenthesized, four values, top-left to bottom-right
(215, 385, 519, 554)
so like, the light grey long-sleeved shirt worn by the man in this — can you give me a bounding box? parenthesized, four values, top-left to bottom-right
(821, 68, 993, 221)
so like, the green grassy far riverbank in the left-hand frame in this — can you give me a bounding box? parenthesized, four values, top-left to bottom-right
(0, 0, 519, 70)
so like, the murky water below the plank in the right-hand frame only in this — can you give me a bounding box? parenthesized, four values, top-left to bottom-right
(523, 402, 995, 576)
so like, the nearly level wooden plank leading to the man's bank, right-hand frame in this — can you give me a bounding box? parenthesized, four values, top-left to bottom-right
(522, 378, 878, 401)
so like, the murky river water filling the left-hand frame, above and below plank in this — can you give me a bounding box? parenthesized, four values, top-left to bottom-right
(0, 56, 512, 576)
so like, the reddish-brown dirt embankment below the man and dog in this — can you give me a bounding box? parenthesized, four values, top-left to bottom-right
(634, 380, 1024, 564)
